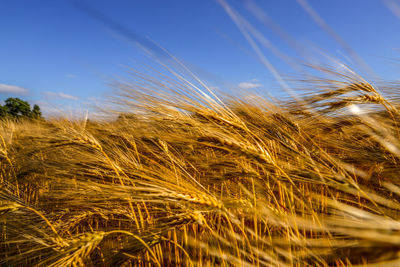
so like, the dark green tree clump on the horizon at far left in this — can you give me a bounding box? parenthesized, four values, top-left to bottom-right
(0, 97, 42, 119)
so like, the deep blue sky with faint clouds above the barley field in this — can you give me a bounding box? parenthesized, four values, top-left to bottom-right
(0, 0, 400, 116)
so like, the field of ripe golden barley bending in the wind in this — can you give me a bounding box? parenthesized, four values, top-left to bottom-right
(0, 64, 400, 266)
